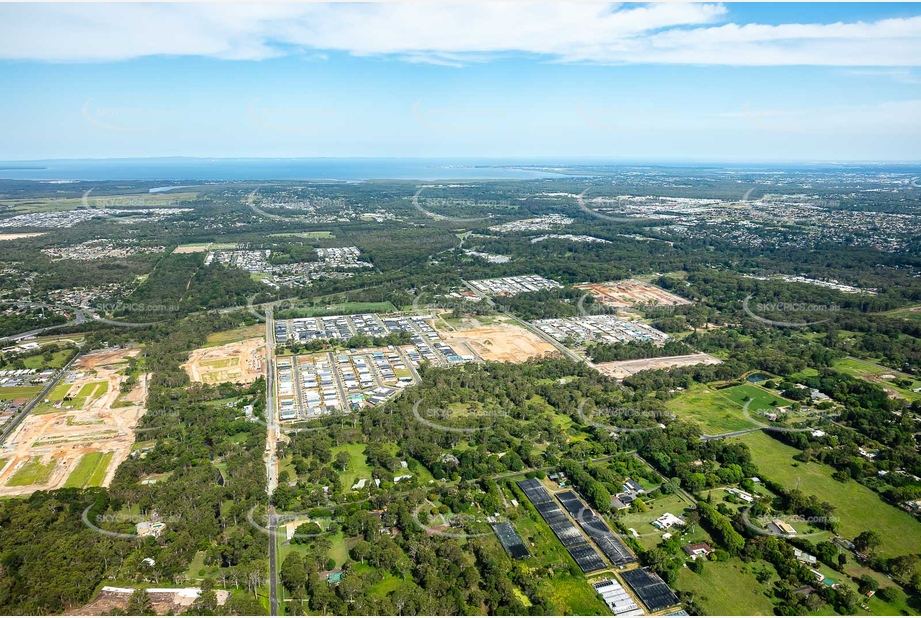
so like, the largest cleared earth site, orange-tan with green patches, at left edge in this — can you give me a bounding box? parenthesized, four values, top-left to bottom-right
(0, 350, 147, 496)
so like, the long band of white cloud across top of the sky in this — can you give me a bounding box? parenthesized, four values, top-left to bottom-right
(0, 3, 921, 67)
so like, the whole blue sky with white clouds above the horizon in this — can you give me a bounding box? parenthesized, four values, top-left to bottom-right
(0, 3, 921, 161)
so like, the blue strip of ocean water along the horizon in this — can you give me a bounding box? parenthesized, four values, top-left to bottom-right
(0, 158, 584, 182)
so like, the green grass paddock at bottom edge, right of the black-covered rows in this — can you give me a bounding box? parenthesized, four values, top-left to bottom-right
(675, 558, 777, 616)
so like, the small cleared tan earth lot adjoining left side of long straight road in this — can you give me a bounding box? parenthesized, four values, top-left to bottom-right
(182, 337, 265, 384)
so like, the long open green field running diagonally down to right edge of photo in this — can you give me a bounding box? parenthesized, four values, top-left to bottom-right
(733, 431, 921, 556)
